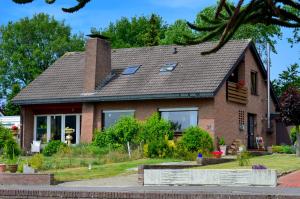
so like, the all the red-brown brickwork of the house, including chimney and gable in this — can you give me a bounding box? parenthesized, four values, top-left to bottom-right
(22, 38, 276, 149)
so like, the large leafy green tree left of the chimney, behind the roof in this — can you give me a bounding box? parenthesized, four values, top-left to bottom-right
(0, 14, 84, 97)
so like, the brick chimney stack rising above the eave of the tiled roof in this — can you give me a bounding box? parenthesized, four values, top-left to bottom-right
(84, 35, 111, 93)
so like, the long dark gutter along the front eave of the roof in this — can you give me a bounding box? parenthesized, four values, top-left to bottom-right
(13, 92, 214, 105)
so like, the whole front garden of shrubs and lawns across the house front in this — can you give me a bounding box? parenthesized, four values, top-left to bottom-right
(0, 114, 300, 182)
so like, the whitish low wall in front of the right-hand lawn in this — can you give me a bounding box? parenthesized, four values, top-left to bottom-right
(144, 169, 277, 187)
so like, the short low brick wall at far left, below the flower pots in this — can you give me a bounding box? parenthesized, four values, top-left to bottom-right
(0, 173, 54, 185)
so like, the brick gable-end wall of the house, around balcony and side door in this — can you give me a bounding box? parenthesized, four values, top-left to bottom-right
(215, 49, 276, 148)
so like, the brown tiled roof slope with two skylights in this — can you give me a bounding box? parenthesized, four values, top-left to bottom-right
(14, 40, 250, 104)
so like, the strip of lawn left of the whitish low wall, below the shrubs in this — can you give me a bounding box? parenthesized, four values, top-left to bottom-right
(45, 159, 181, 182)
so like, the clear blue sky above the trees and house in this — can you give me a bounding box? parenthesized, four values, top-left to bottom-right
(0, 0, 300, 79)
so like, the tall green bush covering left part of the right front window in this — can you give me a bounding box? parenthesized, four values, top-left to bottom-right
(139, 113, 174, 158)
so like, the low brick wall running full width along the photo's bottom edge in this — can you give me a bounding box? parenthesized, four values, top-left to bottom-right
(0, 187, 300, 199)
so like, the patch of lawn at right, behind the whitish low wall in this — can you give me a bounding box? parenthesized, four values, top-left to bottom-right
(199, 154, 300, 175)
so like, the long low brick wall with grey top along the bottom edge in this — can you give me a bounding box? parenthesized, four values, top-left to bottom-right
(0, 186, 300, 199)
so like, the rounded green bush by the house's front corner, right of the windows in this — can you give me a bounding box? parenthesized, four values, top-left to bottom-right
(179, 127, 214, 155)
